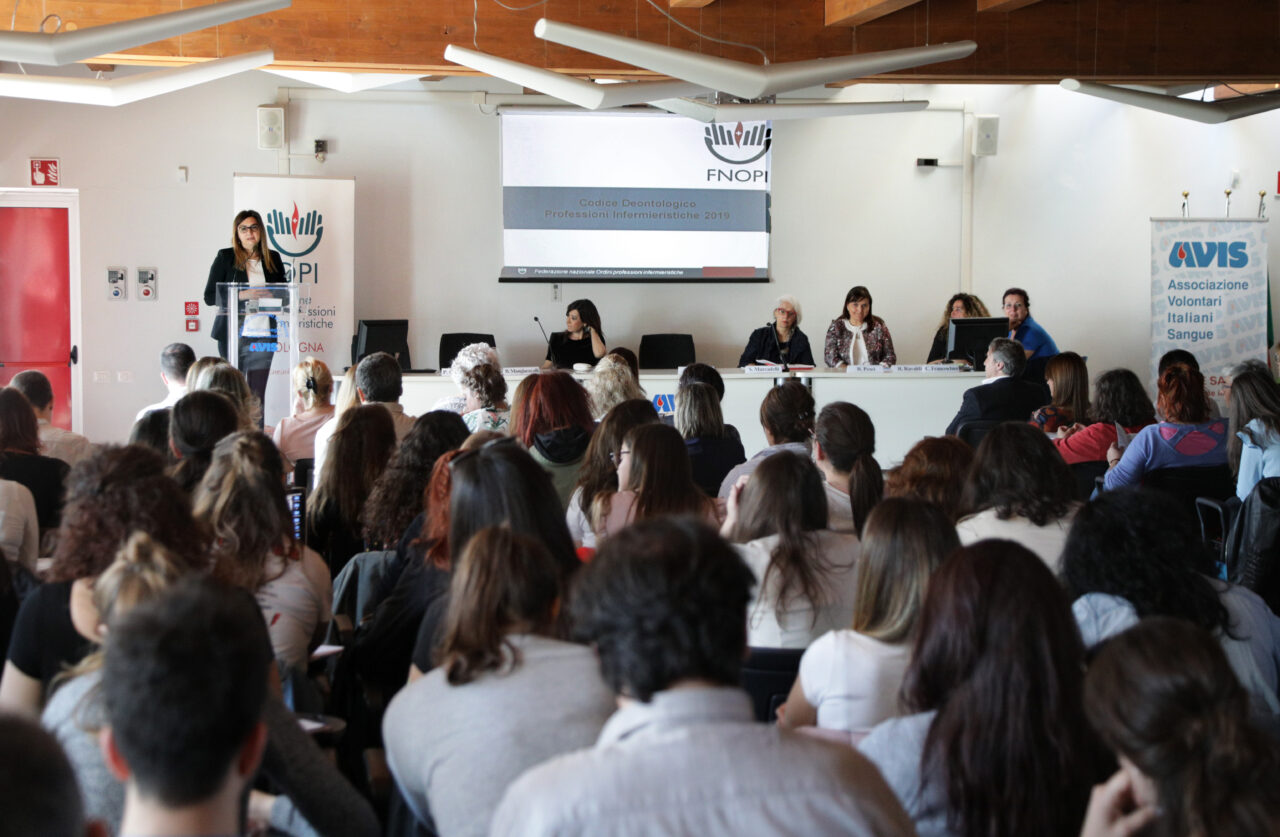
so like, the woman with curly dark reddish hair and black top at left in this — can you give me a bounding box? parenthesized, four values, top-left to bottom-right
(0, 445, 207, 712)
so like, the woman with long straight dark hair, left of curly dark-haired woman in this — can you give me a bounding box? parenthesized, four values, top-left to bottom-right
(306, 404, 396, 576)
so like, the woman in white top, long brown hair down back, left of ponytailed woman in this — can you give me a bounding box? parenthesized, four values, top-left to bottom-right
(721, 450, 859, 648)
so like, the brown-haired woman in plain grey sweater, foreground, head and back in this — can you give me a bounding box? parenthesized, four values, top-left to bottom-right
(383, 527, 614, 837)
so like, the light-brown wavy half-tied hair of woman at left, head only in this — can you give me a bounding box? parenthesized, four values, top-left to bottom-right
(192, 433, 297, 591)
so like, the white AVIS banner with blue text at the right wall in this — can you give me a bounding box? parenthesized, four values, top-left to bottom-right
(1151, 218, 1270, 408)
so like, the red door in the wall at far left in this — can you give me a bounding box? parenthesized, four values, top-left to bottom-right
(0, 206, 72, 430)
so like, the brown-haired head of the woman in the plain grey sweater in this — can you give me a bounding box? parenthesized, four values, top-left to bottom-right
(435, 526, 563, 686)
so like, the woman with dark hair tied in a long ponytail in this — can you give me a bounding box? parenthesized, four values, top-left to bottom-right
(813, 401, 884, 535)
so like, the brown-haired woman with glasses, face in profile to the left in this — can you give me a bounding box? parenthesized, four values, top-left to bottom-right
(591, 424, 719, 541)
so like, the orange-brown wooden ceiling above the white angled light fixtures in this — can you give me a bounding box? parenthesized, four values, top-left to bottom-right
(14, 0, 1280, 86)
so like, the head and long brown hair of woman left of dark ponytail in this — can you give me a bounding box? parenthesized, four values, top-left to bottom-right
(730, 450, 828, 613)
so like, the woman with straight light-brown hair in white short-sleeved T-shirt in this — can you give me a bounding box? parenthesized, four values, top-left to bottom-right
(778, 499, 960, 738)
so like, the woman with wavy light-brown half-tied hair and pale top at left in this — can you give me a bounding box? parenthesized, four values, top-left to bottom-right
(195, 433, 333, 672)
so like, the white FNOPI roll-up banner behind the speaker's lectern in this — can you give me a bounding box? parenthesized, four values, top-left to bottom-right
(233, 174, 356, 425)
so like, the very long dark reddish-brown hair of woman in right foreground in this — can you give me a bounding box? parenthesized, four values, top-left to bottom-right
(902, 540, 1106, 837)
